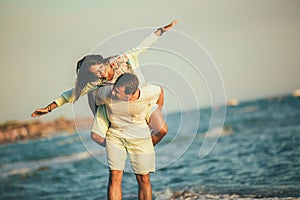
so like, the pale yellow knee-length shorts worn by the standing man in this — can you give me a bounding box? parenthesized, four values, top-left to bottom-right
(106, 134, 155, 174)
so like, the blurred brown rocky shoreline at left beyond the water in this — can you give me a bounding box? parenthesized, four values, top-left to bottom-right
(0, 117, 90, 145)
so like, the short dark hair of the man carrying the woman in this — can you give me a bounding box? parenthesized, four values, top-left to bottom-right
(115, 73, 139, 94)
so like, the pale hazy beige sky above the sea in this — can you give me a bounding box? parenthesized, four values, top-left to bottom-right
(0, 0, 300, 123)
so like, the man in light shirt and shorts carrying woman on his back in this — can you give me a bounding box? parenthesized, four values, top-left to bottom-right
(92, 73, 167, 199)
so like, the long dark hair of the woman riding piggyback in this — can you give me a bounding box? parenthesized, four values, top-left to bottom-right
(74, 55, 104, 103)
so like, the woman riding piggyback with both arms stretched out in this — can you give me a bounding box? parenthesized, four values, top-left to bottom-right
(31, 20, 178, 142)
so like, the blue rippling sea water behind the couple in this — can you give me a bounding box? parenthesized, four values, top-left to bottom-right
(0, 96, 300, 200)
